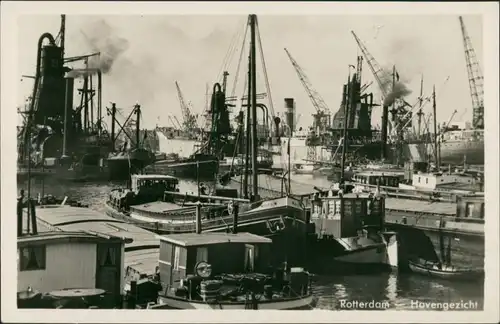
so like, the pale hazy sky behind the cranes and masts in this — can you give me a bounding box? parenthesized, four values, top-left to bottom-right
(17, 15, 484, 128)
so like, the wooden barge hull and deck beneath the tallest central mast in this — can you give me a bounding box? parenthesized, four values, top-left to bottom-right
(106, 175, 309, 264)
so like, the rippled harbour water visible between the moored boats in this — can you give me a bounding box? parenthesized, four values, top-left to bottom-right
(18, 176, 484, 310)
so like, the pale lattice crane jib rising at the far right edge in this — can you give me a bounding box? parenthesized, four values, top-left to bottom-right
(458, 16, 484, 129)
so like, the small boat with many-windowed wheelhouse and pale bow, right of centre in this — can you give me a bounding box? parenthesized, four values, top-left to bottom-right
(310, 185, 398, 273)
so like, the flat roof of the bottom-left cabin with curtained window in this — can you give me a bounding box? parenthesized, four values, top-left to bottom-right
(17, 231, 132, 247)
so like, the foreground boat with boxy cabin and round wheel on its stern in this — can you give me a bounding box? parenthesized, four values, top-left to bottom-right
(148, 209, 317, 310)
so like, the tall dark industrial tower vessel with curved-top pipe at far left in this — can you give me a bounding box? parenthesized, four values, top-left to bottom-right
(17, 15, 112, 179)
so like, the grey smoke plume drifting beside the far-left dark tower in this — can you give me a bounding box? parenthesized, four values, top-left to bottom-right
(69, 19, 129, 77)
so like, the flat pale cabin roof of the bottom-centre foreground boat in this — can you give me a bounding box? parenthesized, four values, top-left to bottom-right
(158, 233, 272, 247)
